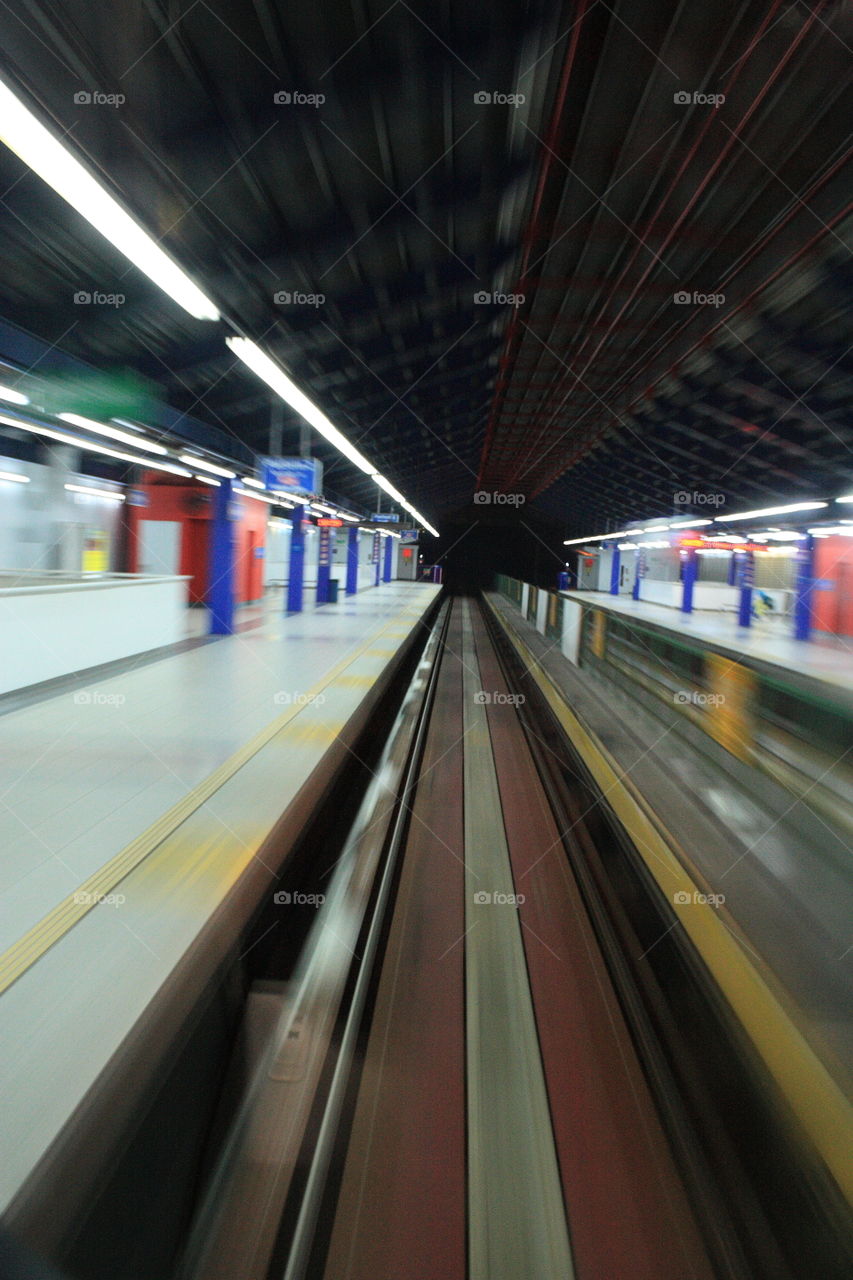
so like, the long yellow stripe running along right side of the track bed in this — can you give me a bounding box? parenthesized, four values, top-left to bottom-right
(488, 602, 853, 1203)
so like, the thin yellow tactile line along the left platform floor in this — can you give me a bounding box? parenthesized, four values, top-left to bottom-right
(0, 593, 435, 995)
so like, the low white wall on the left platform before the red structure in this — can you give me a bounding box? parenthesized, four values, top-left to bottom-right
(0, 577, 187, 694)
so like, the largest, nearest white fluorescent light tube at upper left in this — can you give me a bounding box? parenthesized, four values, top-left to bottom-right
(0, 81, 219, 320)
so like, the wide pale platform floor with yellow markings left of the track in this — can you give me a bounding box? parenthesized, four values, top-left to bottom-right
(0, 582, 439, 1210)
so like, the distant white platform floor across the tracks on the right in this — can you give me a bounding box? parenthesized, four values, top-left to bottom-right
(560, 591, 853, 690)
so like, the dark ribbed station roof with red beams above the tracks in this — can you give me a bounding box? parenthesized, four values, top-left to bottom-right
(0, 0, 853, 536)
